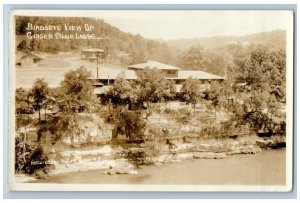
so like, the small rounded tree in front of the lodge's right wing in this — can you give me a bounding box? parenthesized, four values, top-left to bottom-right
(181, 77, 202, 109)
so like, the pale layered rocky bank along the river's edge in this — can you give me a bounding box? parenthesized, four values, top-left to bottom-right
(17, 137, 285, 182)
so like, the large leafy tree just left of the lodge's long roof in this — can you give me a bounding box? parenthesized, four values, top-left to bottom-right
(55, 67, 99, 141)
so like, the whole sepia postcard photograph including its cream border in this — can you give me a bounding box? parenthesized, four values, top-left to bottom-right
(8, 10, 294, 192)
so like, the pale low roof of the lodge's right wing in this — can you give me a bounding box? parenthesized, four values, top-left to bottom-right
(167, 70, 224, 80)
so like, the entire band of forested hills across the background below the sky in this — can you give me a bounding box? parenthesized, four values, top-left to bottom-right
(16, 16, 286, 76)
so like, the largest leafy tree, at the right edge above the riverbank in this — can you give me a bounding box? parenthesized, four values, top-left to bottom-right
(231, 46, 286, 130)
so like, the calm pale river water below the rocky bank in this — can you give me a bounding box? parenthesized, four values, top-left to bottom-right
(33, 149, 286, 185)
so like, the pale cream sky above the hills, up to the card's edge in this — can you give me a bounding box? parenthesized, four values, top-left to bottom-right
(92, 10, 292, 40)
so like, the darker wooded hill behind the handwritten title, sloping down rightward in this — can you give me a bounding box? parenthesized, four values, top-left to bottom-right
(16, 16, 171, 63)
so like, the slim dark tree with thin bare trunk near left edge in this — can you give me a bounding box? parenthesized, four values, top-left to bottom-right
(30, 78, 49, 123)
